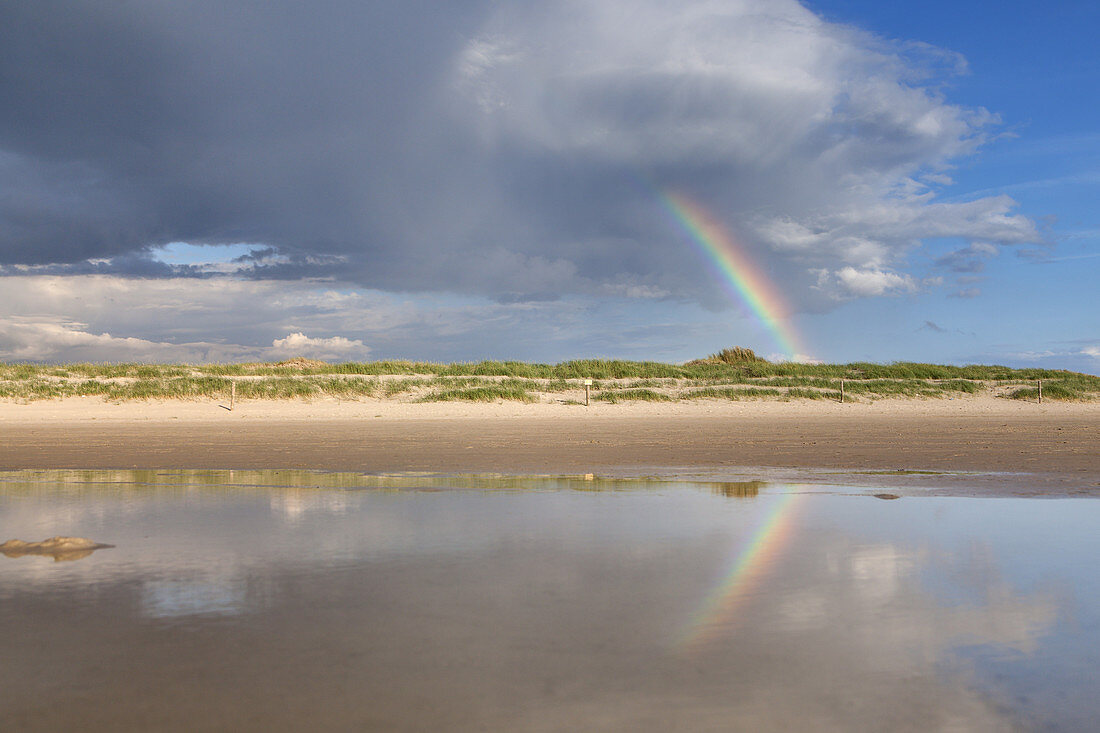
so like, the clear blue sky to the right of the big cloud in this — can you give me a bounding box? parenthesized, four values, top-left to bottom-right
(810, 0, 1100, 365)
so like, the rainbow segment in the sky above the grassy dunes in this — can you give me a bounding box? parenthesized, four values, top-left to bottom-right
(658, 189, 805, 361)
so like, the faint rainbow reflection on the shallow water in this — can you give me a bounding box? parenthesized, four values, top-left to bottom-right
(675, 486, 803, 649)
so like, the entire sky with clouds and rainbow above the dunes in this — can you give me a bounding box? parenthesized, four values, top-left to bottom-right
(0, 0, 1100, 365)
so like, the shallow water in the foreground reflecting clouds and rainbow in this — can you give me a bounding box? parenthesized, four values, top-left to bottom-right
(0, 471, 1100, 731)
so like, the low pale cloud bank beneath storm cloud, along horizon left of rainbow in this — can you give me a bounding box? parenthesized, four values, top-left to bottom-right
(0, 275, 783, 362)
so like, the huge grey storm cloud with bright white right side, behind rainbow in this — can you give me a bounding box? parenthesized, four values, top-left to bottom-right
(0, 0, 1035, 308)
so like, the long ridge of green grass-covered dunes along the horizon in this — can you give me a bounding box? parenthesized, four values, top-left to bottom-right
(0, 359, 1100, 403)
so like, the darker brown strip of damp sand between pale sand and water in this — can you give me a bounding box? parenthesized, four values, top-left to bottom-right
(0, 409, 1100, 495)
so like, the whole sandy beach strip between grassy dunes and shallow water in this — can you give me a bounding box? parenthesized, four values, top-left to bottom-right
(0, 397, 1100, 494)
